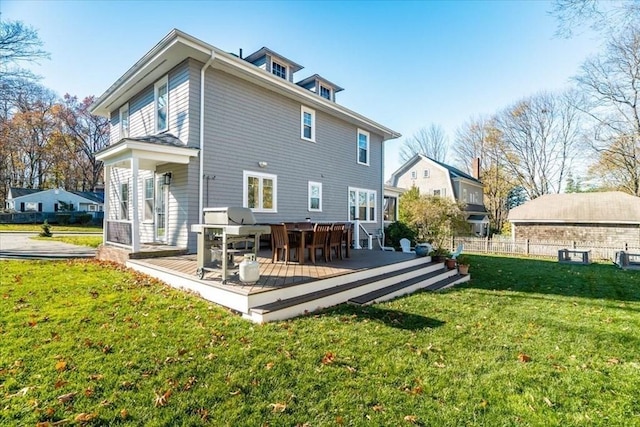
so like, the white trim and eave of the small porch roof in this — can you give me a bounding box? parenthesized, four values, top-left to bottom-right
(96, 139, 200, 170)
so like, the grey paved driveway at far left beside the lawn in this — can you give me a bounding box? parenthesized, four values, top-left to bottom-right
(0, 233, 96, 259)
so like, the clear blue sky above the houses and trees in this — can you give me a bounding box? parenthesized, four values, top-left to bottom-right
(0, 0, 598, 177)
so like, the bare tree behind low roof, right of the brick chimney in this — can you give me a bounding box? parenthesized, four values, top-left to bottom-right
(495, 92, 580, 199)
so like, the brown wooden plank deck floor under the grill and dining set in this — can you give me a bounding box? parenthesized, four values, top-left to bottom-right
(129, 250, 415, 295)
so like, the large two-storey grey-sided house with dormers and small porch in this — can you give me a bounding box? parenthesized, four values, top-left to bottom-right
(92, 30, 400, 252)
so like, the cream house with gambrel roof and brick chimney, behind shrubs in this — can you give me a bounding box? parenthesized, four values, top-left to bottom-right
(388, 154, 489, 236)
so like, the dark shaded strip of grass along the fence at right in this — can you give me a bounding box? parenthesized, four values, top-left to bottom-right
(459, 255, 640, 301)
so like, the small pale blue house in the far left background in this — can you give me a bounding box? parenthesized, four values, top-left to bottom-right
(6, 187, 104, 212)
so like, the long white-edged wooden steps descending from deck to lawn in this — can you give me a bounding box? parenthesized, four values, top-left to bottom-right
(245, 258, 469, 323)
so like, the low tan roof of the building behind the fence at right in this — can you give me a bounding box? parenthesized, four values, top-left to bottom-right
(508, 191, 640, 224)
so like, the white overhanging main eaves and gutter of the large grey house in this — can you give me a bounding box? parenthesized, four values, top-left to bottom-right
(91, 29, 402, 140)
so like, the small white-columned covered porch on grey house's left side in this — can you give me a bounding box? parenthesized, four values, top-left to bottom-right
(96, 134, 199, 254)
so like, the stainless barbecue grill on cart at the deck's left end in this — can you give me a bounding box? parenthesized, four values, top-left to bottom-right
(191, 207, 271, 283)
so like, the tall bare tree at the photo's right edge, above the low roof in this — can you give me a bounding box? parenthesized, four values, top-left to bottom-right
(576, 28, 640, 196)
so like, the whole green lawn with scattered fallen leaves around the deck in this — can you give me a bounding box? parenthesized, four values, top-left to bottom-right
(0, 256, 640, 426)
